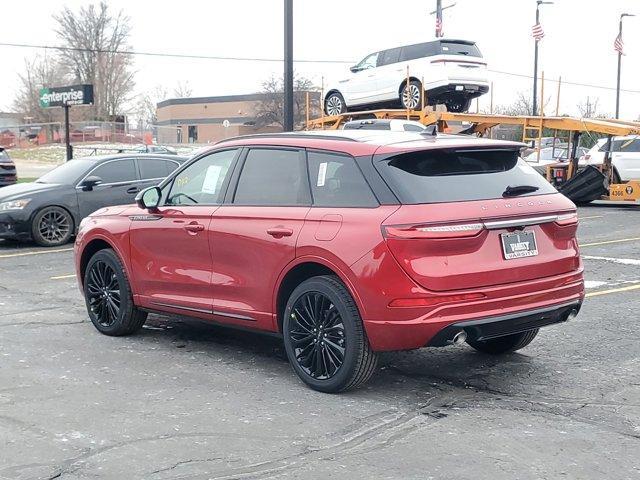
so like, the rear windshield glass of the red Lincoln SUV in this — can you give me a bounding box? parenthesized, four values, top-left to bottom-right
(375, 149, 556, 204)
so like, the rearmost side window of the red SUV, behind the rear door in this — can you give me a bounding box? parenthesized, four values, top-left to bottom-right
(308, 152, 378, 207)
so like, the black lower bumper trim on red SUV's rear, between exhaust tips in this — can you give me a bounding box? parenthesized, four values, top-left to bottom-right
(427, 300, 582, 347)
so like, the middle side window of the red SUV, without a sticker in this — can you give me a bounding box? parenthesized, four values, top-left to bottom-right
(233, 148, 310, 206)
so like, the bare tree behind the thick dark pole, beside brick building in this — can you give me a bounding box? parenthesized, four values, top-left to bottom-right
(256, 76, 320, 128)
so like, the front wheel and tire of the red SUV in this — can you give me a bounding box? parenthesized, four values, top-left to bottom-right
(84, 248, 147, 337)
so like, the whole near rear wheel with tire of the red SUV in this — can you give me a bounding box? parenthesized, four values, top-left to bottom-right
(282, 276, 378, 393)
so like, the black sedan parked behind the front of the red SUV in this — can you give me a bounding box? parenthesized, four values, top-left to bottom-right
(0, 154, 186, 247)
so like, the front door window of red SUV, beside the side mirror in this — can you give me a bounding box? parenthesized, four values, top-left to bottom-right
(166, 149, 237, 205)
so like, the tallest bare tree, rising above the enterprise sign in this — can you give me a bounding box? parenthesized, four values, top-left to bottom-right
(53, 1, 134, 119)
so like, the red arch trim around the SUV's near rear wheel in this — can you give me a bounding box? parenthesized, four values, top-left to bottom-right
(273, 256, 363, 332)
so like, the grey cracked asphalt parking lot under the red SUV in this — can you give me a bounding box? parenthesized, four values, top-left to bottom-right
(0, 206, 640, 479)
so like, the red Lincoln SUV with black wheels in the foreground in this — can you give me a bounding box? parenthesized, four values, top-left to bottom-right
(75, 130, 584, 392)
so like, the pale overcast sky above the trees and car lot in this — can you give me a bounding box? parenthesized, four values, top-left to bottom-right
(0, 0, 640, 119)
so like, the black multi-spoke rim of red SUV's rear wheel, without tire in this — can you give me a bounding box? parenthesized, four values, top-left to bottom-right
(289, 292, 346, 380)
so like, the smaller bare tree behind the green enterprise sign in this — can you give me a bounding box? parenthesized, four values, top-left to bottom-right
(13, 55, 68, 123)
